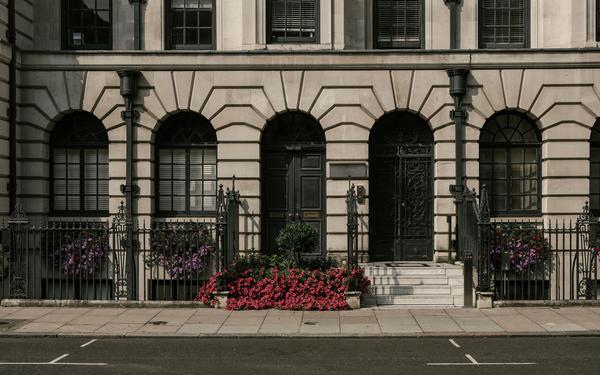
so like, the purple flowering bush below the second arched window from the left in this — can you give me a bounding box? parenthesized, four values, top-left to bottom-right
(146, 223, 214, 279)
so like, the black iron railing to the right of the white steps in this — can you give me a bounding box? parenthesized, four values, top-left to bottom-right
(457, 186, 600, 301)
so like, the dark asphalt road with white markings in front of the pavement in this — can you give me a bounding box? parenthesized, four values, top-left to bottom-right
(0, 337, 600, 375)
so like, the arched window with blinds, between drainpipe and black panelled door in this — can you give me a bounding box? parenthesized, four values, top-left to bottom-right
(156, 112, 217, 216)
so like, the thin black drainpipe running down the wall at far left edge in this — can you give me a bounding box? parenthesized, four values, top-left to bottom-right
(6, 0, 17, 212)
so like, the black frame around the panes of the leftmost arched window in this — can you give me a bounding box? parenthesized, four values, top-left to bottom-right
(49, 112, 110, 217)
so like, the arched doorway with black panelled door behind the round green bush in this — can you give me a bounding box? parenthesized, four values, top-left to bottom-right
(261, 112, 325, 256)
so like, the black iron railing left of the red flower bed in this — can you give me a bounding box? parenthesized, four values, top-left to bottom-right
(0, 186, 239, 300)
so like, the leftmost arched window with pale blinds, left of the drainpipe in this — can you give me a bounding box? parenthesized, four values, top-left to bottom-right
(50, 112, 108, 215)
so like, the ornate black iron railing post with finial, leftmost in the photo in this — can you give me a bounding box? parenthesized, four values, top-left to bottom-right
(8, 203, 29, 298)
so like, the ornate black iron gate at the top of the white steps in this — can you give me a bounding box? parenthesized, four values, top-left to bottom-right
(369, 144, 433, 261)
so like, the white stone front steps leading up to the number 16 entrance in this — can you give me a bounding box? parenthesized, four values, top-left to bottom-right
(362, 262, 464, 307)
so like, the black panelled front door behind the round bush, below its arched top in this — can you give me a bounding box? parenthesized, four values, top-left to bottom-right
(261, 146, 325, 256)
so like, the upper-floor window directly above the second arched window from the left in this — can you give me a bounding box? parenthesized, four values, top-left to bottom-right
(165, 0, 215, 49)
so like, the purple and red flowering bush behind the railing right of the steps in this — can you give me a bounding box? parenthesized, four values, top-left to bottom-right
(490, 223, 550, 273)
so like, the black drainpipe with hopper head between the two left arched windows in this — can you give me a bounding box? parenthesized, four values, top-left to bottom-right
(117, 70, 140, 300)
